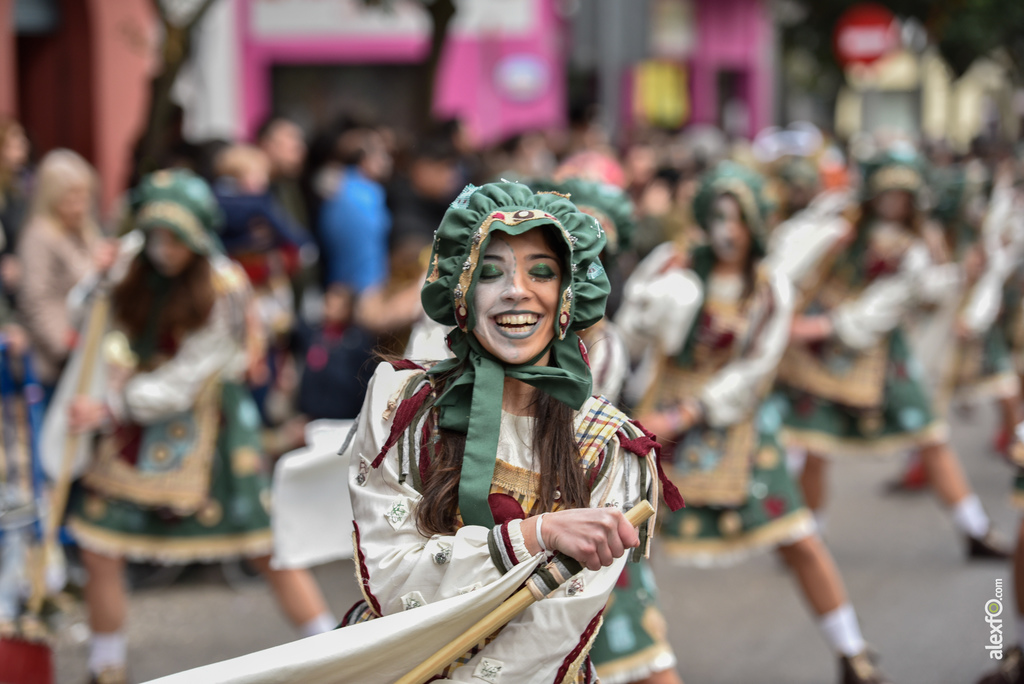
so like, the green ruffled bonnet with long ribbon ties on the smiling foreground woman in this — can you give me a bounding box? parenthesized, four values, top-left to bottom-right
(421, 182, 609, 525)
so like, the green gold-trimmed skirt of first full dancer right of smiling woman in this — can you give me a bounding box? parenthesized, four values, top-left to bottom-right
(658, 396, 815, 567)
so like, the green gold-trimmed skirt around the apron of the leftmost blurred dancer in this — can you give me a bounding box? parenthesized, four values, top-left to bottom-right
(68, 383, 271, 564)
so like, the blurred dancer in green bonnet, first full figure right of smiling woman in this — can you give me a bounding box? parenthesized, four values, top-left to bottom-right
(621, 162, 888, 684)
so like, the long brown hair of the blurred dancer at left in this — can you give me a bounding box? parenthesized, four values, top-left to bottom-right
(112, 252, 217, 348)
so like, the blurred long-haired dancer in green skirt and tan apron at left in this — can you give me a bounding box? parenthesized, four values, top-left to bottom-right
(51, 171, 335, 684)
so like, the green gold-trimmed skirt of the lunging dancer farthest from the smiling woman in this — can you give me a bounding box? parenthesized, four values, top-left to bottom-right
(778, 329, 947, 456)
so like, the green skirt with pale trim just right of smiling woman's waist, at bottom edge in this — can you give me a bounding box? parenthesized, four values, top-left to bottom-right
(590, 560, 676, 684)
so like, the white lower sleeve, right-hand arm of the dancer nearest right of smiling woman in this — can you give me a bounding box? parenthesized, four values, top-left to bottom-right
(700, 273, 794, 427)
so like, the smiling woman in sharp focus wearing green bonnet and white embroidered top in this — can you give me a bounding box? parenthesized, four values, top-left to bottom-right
(345, 183, 678, 684)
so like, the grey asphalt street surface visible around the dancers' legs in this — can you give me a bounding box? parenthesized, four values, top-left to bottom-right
(56, 410, 1019, 684)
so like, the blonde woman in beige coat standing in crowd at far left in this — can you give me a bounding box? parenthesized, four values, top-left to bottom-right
(17, 149, 117, 393)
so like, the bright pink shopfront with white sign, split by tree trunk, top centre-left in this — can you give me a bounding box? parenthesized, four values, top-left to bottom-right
(236, 0, 566, 143)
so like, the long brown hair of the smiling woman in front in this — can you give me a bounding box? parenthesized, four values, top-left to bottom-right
(416, 370, 590, 537)
